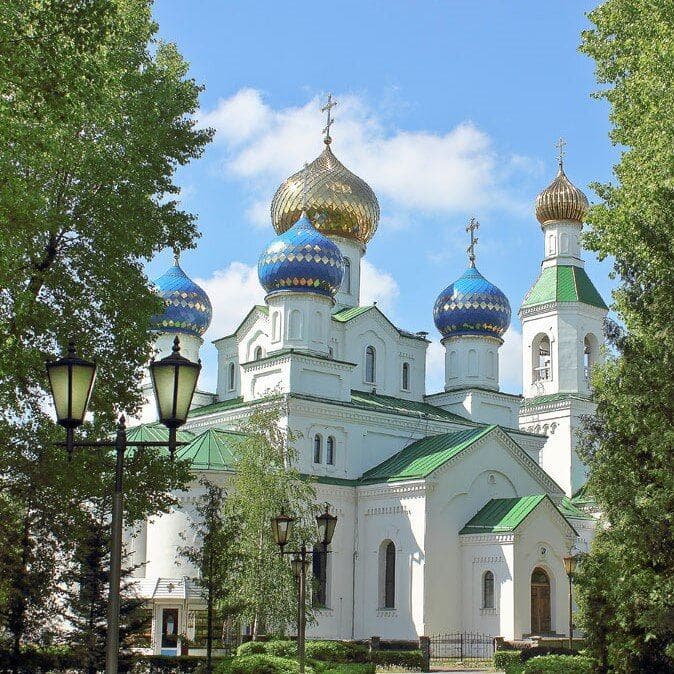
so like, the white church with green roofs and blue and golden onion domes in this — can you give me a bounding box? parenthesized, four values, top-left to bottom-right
(127, 118, 607, 654)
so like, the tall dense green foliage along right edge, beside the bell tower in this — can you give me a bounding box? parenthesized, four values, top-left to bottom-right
(579, 0, 674, 672)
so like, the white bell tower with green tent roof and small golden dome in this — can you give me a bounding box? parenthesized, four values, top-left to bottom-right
(519, 139, 608, 496)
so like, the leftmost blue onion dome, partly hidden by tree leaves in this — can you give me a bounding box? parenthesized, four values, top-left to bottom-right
(152, 254, 213, 337)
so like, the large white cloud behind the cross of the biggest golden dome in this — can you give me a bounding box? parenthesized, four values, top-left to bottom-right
(201, 89, 535, 224)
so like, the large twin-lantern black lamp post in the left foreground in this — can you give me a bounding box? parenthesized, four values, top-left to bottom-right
(47, 337, 201, 674)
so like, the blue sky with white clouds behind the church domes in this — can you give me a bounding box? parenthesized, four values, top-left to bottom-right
(148, 0, 616, 391)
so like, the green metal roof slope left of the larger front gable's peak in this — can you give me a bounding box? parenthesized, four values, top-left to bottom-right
(360, 426, 496, 484)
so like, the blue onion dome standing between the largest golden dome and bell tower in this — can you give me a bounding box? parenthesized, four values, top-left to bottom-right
(433, 267, 510, 339)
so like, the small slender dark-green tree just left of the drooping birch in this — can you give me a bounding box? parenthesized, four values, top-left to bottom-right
(179, 479, 242, 674)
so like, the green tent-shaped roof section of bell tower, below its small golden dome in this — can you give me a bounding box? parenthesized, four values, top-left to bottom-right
(522, 265, 608, 309)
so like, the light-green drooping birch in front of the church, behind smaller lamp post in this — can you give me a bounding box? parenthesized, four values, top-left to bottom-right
(227, 397, 316, 639)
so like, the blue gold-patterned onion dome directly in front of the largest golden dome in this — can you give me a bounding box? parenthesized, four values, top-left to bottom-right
(257, 213, 344, 297)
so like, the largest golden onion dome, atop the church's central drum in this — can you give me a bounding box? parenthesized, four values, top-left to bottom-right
(271, 141, 379, 245)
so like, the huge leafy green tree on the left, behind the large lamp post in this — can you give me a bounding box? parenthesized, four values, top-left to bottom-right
(0, 0, 211, 652)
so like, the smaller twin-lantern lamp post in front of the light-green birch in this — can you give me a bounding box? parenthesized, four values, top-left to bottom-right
(271, 503, 337, 674)
